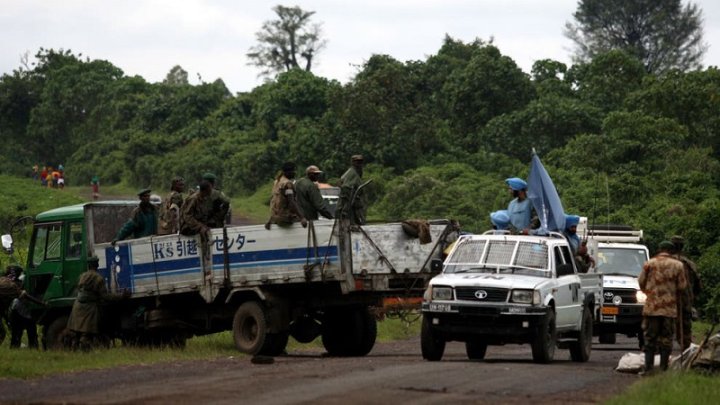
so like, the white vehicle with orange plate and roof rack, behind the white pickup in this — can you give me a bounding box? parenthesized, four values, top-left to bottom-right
(578, 221, 650, 347)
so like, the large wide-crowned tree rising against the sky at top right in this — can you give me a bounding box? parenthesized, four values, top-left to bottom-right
(565, 0, 707, 73)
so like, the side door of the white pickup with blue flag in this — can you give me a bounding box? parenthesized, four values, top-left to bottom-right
(553, 246, 580, 327)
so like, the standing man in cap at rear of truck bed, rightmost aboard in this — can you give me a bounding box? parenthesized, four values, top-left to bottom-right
(336, 155, 367, 225)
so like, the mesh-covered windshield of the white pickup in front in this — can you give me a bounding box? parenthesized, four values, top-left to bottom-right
(444, 239, 551, 277)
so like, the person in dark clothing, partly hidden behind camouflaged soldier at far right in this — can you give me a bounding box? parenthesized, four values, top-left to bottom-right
(670, 235, 702, 350)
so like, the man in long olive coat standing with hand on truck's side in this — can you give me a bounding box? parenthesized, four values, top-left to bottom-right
(67, 256, 129, 351)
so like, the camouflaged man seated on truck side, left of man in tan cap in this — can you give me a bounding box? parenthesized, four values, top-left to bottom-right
(265, 162, 307, 229)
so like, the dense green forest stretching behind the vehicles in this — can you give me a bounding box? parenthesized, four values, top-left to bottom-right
(0, 37, 720, 318)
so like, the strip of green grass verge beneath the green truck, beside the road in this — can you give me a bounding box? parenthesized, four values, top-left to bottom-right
(0, 319, 419, 379)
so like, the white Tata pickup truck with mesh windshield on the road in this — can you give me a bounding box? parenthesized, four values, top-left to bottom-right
(421, 231, 602, 363)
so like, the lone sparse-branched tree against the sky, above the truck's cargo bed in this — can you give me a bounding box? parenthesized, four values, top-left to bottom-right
(247, 5, 326, 76)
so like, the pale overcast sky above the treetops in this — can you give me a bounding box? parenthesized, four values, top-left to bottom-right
(0, 0, 720, 93)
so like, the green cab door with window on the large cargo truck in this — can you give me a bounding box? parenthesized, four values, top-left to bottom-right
(27, 222, 65, 300)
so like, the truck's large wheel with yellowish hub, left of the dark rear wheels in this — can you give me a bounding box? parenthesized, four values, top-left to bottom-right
(233, 301, 268, 354)
